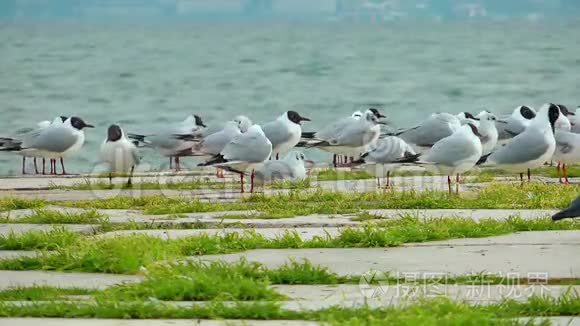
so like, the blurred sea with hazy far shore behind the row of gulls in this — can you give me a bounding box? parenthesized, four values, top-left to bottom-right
(0, 0, 580, 174)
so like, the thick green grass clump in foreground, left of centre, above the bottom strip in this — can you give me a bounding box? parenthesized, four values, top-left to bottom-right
(98, 260, 339, 301)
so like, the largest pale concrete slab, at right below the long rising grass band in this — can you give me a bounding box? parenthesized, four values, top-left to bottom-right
(192, 231, 580, 278)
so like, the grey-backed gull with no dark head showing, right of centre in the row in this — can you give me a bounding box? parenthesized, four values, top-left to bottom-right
(394, 113, 461, 152)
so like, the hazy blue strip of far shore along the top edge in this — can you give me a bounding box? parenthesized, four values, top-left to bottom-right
(0, 0, 580, 22)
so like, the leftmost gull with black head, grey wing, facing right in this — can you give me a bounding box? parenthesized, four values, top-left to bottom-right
(0, 117, 94, 175)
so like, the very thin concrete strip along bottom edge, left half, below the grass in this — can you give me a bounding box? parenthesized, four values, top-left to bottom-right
(0, 318, 319, 326)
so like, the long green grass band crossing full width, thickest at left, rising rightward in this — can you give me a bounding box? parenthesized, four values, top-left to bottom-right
(0, 216, 580, 274)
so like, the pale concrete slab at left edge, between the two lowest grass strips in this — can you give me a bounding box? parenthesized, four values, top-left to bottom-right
(0, 270, 142, 290)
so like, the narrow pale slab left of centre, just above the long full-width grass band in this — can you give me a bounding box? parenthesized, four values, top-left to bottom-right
(99, 228, 340, 241)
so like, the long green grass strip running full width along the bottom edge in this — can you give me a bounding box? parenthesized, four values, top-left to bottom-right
(0, 295, 580, 326)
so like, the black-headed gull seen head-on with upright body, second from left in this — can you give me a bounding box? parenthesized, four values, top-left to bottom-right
(101, 124, 141, 186)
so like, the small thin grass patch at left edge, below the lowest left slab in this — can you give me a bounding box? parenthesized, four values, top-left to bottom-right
(0, 286, 95, 301)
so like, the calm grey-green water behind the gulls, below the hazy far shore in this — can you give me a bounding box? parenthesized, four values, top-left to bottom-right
(0, 22, 580, 175)
